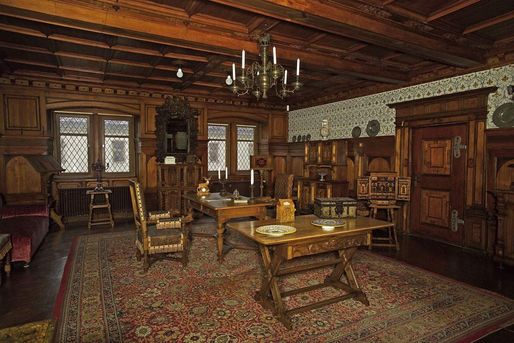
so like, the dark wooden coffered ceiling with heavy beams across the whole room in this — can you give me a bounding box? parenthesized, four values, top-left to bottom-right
(0, 0, 514, 108)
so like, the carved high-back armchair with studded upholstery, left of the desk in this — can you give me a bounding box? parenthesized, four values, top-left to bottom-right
(130, 181, 190, 271)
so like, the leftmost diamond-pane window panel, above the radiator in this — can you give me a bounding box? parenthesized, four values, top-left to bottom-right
(59, 115, 89, 173)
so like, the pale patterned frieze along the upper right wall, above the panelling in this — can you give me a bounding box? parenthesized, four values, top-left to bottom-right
(288, 64, 514, 142)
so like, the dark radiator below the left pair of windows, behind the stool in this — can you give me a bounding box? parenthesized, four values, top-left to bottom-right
(58, 186, 132, 217)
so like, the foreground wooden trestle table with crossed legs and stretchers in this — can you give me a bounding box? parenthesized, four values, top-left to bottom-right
(227, 215, 392, 329)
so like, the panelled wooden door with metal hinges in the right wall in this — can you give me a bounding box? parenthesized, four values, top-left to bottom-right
(410, 124, 467, 245)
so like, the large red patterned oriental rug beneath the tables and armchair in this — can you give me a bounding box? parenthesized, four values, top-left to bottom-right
(55, 232, 514, 343)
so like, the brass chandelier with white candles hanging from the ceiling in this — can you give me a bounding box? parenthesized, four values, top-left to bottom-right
(225, 34, 302, 100)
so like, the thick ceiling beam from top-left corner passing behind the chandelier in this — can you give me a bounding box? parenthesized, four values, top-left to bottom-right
(0, 0, 407, 84)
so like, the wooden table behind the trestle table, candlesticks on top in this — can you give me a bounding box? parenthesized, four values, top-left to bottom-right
(183, 193, 273, 262)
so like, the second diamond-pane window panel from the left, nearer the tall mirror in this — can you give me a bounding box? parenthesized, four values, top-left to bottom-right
(104, 119, 130, 173)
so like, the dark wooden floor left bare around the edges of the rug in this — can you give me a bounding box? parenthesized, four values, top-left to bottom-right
(0, 217, 514, 343)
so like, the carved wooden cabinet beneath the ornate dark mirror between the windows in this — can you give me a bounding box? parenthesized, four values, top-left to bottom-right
(157, 163, 202, 214)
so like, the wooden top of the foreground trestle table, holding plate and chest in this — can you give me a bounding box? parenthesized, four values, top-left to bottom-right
(227, 215, 393, 245)
